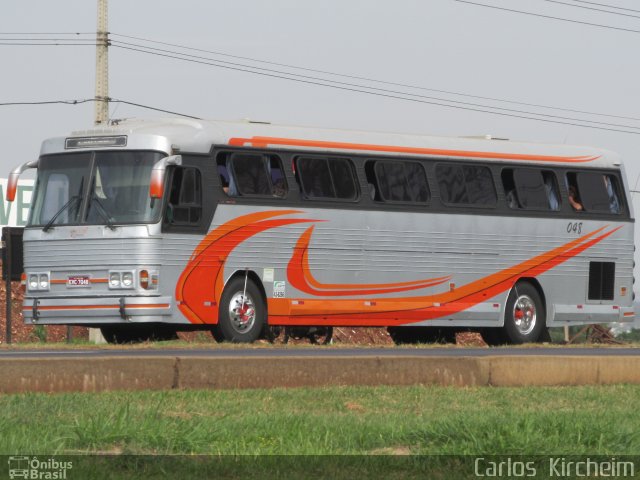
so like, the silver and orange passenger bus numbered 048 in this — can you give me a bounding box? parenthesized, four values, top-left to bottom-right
(7, 119, 634, 345)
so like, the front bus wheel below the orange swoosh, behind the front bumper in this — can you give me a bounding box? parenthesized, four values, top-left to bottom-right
(213, 276, 267, 343)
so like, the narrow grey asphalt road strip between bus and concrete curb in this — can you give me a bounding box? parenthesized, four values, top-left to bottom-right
(0, 347, 640, 359)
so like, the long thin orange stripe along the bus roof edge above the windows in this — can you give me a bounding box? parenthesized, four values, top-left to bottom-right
(229, 137, 600, 163)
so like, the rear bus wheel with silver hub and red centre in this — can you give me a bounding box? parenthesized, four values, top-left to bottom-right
(504, 282, 547, 345)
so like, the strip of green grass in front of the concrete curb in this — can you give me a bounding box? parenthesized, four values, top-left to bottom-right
(0, 386, 640, 480)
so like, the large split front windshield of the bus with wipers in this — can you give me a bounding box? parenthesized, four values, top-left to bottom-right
(28, 151, 163, 227)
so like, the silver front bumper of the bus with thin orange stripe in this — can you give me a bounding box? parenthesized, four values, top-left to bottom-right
(22, 296, 174, 325)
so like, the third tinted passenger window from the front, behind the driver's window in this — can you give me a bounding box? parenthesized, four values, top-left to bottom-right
(375, 161, 429, 203)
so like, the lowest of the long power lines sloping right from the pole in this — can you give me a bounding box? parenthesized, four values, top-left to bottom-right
(113, 43, 640, 135)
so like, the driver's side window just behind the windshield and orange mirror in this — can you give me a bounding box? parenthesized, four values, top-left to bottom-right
(166, 167, 202, 226)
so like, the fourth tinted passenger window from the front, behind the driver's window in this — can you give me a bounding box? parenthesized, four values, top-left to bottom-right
(436, 164, 497, 207)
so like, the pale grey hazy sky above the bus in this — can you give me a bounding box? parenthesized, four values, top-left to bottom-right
(0, 0, 640, 284)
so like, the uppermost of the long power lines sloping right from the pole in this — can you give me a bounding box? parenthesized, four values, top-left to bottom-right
(111, 33, 640, 121)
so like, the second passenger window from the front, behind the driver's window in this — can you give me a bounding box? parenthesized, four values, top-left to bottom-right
(296, 157, 357, 200)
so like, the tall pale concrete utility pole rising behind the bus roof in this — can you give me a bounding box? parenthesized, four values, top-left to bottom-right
(95, 0, 109, 125)
